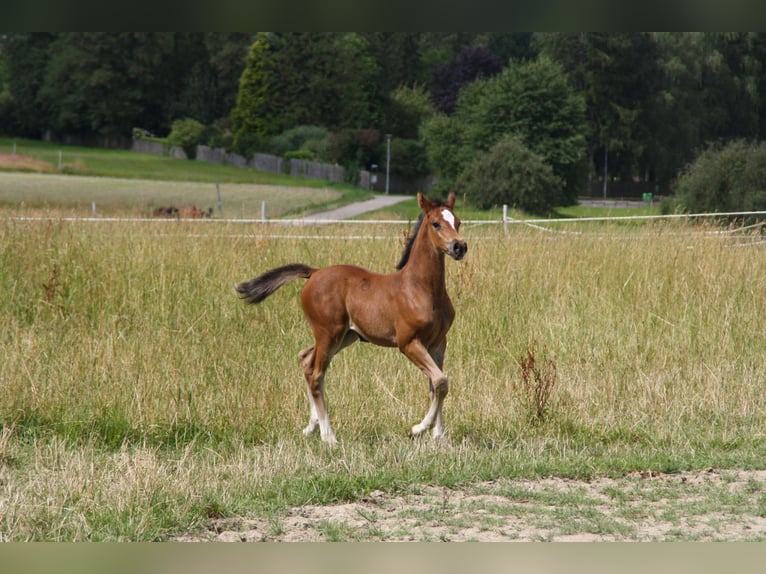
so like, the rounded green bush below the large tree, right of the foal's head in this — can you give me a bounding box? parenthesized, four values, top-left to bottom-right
(457, 136, 563, 213)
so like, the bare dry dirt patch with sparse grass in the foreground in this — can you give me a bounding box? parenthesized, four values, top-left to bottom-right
(177, 469, 766, 542)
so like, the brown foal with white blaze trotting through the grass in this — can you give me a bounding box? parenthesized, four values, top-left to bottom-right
(236, 192, 468, 445)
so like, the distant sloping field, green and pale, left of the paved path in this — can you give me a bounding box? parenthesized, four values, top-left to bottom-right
(0, 138, 370, 218)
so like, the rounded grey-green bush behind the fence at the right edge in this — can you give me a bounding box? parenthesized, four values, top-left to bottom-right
(675, 140, 766, 213)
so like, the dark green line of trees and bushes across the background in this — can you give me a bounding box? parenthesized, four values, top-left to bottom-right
(0, 32, 766, 211)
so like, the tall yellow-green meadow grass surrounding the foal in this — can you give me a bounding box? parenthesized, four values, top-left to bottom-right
(0, 221, 766, 540)
